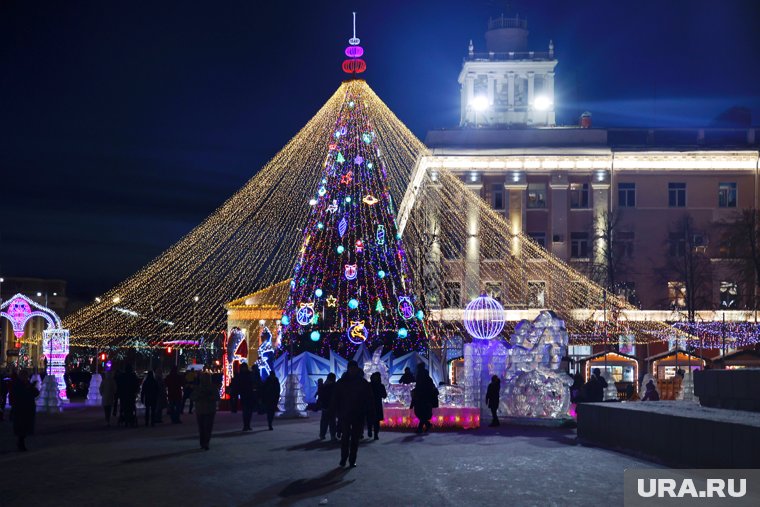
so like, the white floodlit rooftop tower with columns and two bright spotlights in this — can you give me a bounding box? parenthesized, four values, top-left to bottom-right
(459, 15, 557, 127)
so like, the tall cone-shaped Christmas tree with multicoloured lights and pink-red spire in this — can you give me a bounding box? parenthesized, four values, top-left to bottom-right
(282, 16, 424, 355)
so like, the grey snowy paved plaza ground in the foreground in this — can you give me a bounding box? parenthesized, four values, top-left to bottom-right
(0, 406, 657, 507)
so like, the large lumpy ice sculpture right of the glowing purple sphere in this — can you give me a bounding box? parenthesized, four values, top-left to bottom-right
(501, 311, 572, 419)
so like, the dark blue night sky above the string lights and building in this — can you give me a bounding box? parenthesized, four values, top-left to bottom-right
(0, 0, 760, 299)
